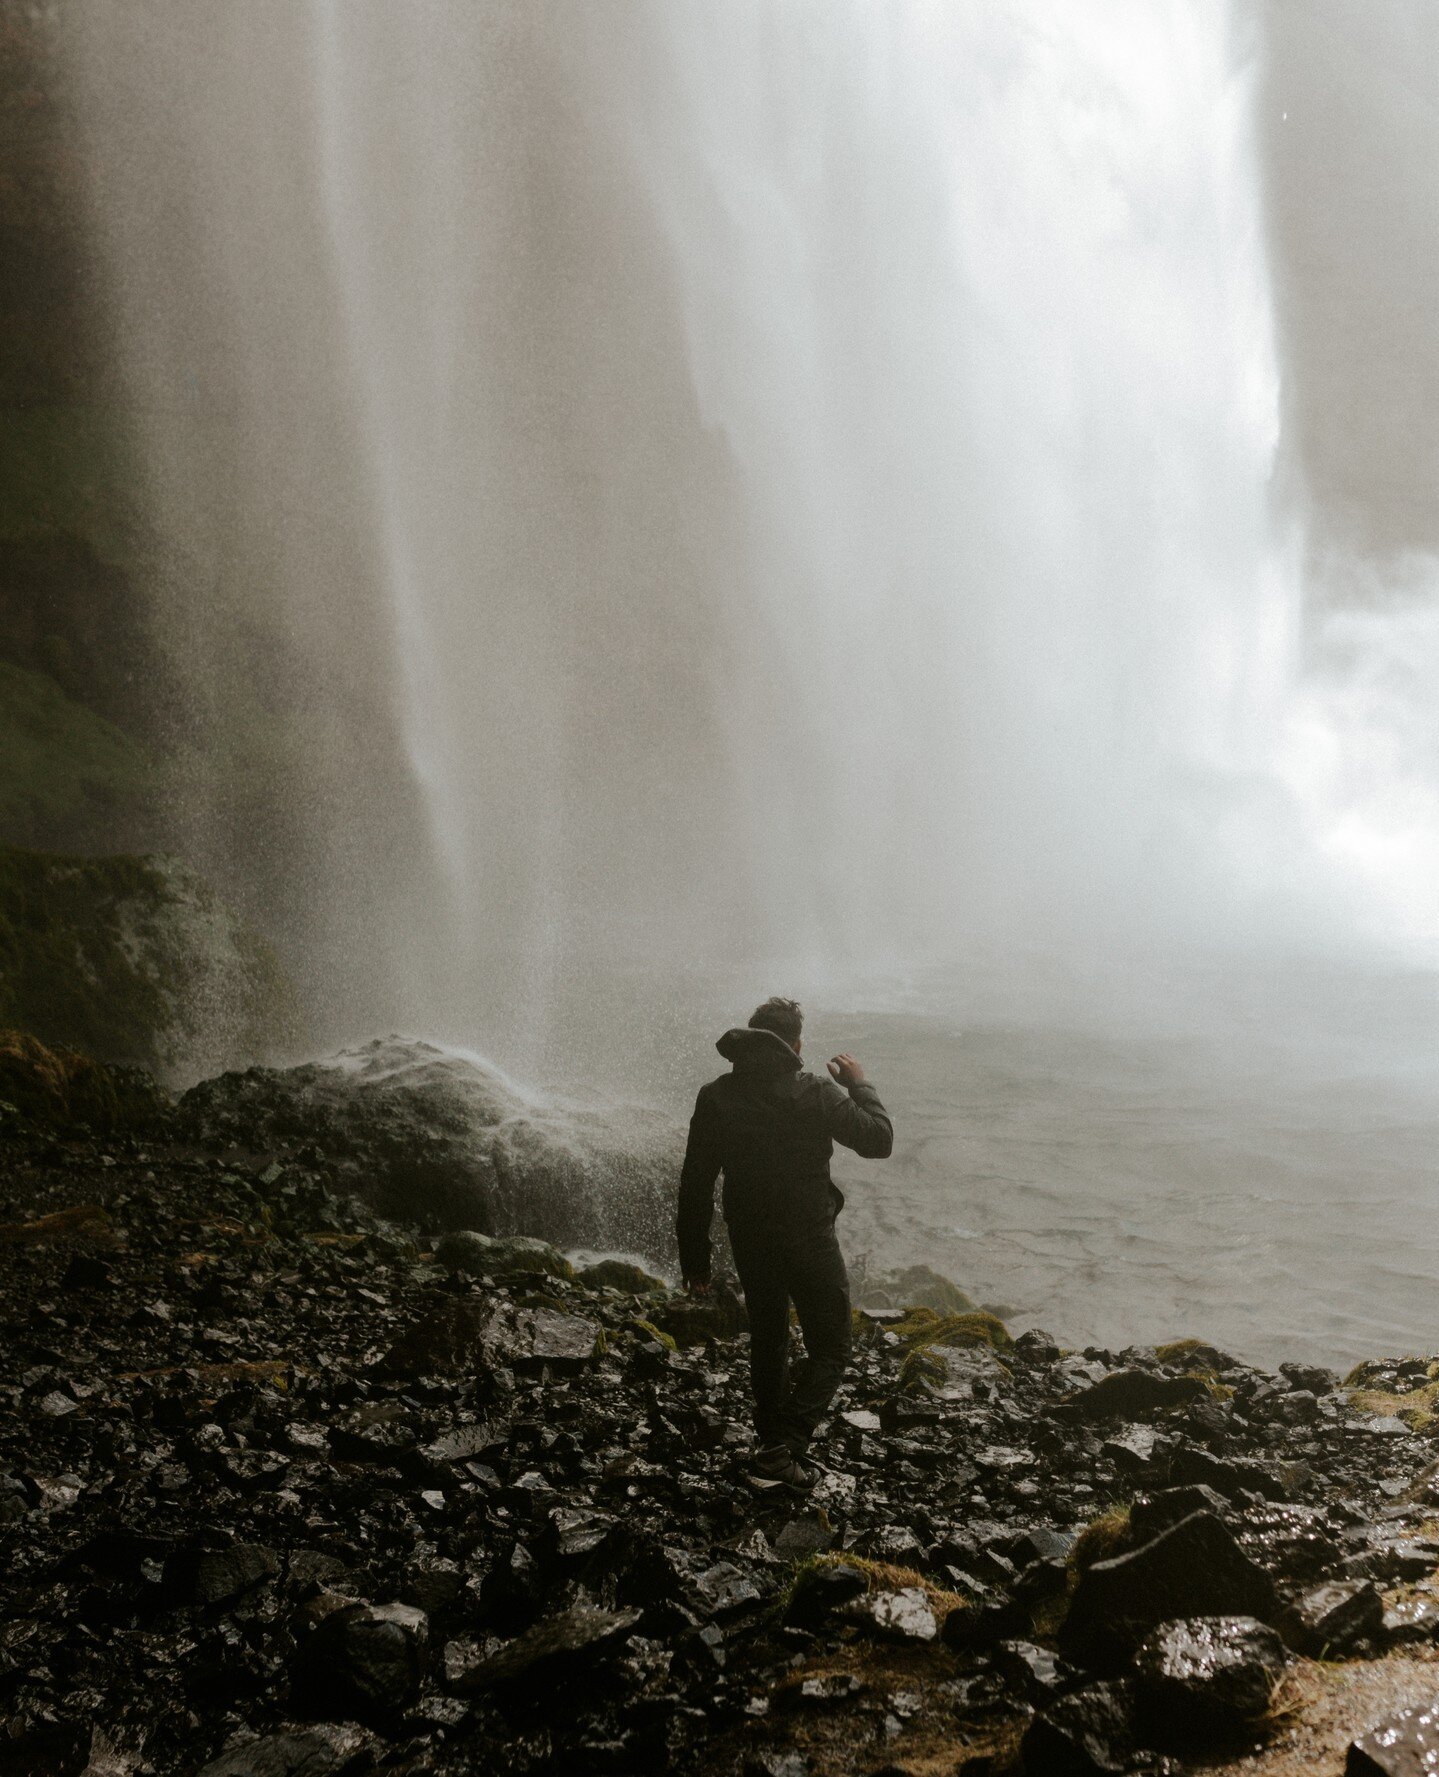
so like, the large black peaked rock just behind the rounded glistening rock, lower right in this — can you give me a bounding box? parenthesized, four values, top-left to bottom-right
(1061, 1512, 1277, 1660)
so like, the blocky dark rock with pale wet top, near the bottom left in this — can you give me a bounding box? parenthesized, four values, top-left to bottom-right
(291, 1603, 430, 1720)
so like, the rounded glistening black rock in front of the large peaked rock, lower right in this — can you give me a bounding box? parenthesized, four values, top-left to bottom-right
(1133, 1617, 1290, 1745)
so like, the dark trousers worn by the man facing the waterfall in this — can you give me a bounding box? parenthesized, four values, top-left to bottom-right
(730, 1223, 851, 1454)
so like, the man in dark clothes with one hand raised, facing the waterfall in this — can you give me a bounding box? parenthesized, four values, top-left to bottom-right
(679, 999, 894, 1487)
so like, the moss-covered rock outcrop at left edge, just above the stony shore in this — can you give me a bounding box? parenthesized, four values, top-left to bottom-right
(0, 848, 304, 1082)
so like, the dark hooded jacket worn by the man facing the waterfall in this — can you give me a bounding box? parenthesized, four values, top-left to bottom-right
(679, 1031, 894, 1283)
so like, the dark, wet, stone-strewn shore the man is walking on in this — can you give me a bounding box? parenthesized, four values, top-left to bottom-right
(0, 1059, 1439, 1777)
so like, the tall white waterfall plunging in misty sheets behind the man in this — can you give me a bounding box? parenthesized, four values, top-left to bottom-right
(59, 0, 1435, 1038)
